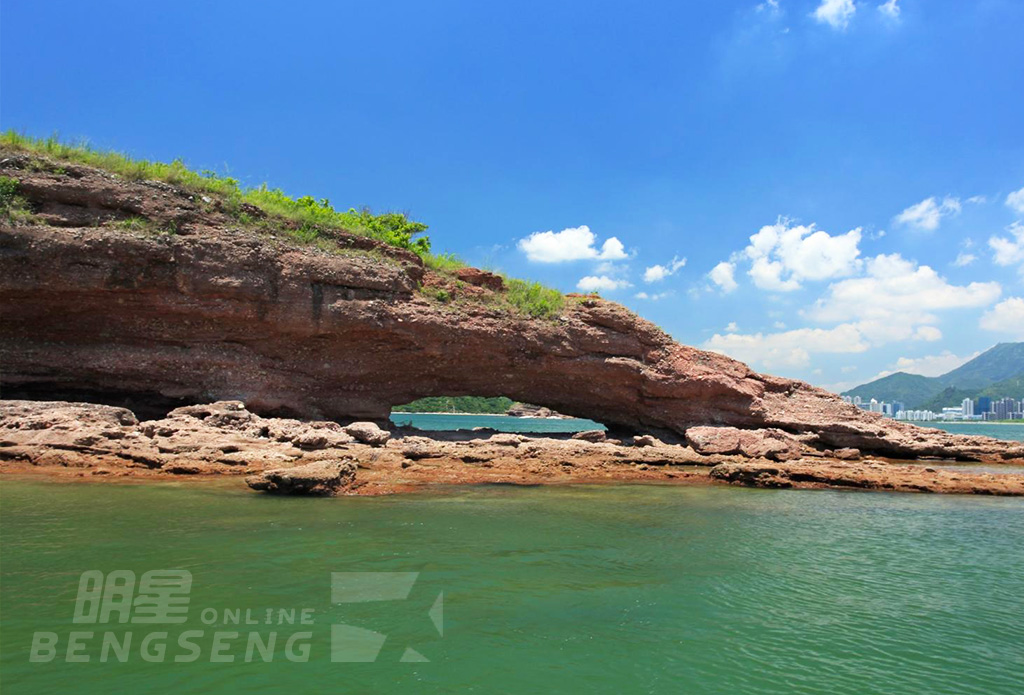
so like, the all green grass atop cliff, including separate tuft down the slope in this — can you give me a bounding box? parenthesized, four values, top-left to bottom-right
(0, 130, 565, 318)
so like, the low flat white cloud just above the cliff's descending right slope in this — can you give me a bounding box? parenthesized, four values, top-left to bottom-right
(703, 323, 869, 368)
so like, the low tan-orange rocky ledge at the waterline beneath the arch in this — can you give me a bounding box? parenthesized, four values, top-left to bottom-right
(0, 400, 1024, 495)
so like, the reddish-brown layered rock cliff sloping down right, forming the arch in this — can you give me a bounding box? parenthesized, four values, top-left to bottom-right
(0, 158, 1024, 461)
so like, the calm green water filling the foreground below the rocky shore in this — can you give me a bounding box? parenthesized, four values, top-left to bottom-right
(0, 477, 1024, 695)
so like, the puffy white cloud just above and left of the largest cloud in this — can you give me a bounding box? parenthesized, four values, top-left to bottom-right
(740, 219, 861, 292)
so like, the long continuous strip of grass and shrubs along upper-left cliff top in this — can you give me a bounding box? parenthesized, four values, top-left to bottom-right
(0, 130, 430, 255)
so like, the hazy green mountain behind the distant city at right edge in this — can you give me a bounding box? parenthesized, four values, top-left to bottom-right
(843, 343, 1024, 410)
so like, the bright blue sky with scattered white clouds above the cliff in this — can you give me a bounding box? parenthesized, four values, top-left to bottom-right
(6, 0, 1024, 388)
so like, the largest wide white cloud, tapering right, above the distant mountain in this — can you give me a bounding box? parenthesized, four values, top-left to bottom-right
(806, 254, 1002, 331)
